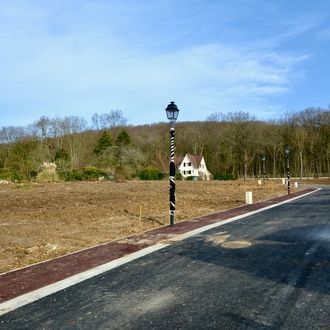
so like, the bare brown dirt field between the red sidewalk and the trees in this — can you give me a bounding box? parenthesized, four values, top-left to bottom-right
(0, 180, 324, 273)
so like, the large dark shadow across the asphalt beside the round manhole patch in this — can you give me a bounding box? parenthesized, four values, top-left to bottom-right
(181, 225, 330, 294)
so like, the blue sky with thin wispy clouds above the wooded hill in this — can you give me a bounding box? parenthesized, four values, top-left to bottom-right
(0, 0, 330, 127)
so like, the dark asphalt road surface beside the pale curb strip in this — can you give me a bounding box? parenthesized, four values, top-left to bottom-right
(0, 187, 330, 329)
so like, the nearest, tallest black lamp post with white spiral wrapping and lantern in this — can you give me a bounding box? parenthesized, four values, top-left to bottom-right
(165, 101, 179, 226)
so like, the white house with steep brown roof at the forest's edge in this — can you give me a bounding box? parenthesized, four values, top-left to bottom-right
(178, 154, 212, 180)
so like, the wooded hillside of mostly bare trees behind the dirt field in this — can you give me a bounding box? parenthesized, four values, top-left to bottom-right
(0, 107, 330, 182)
